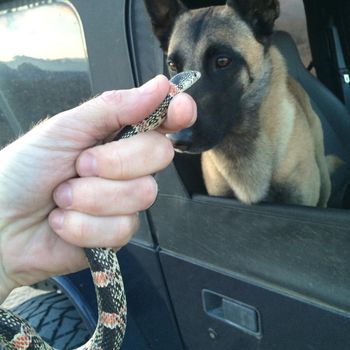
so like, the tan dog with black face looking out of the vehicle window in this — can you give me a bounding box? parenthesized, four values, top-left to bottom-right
(145, 0, 331, 207)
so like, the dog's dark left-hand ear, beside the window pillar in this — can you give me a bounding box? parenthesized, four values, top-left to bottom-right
(144, 0, 187, 51)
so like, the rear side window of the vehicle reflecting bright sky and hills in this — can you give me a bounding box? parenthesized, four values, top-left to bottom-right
(0, 0, 91, 146)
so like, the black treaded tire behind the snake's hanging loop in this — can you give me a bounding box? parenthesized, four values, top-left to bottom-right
(0, 291, 91, 350)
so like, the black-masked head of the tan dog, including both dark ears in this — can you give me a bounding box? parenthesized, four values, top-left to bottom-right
(145, 0, 279, 153)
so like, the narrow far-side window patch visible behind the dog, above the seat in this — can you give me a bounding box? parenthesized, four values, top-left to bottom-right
(275, 0, 312, 67)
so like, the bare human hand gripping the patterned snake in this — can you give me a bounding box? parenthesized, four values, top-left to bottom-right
(0, 76, 196, 300)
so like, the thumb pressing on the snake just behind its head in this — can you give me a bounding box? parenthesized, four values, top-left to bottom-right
(34, 75, 170, 148)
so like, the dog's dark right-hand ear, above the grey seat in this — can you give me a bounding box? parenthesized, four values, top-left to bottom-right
(226, 0, 280, 37)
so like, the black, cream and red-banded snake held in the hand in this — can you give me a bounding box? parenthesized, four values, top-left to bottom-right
(0, 71, 201, 350)
